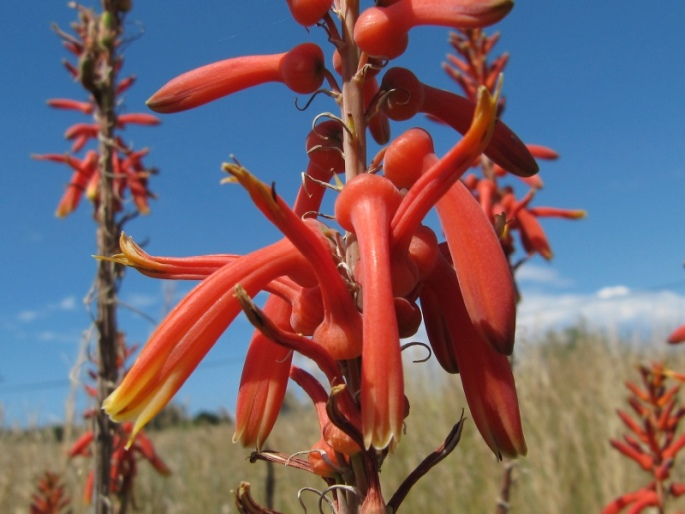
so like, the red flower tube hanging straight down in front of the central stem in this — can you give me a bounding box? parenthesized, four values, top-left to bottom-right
(335, 173, 404, 449)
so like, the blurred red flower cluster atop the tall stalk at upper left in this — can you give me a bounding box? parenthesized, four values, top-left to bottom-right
(33, 0, 159, 217)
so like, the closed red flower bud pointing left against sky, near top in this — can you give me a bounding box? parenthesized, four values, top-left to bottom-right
(147, 43, 325, 113)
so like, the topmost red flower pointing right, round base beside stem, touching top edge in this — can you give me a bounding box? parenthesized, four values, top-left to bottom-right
(354, 0, 514, 59)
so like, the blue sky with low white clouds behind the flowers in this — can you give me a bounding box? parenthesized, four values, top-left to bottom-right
(0, 0, 685, 424)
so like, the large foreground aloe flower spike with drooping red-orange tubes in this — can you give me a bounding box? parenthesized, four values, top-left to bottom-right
(104, 0, 538, 512)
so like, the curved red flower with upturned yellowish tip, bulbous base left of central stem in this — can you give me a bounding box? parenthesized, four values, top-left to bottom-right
(224, 164, 362, 360)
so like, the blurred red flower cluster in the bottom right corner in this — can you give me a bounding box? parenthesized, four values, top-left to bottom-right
(602, 363, 685, 514)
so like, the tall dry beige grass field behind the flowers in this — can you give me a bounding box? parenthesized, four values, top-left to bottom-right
(0, 327, 685, 514)
